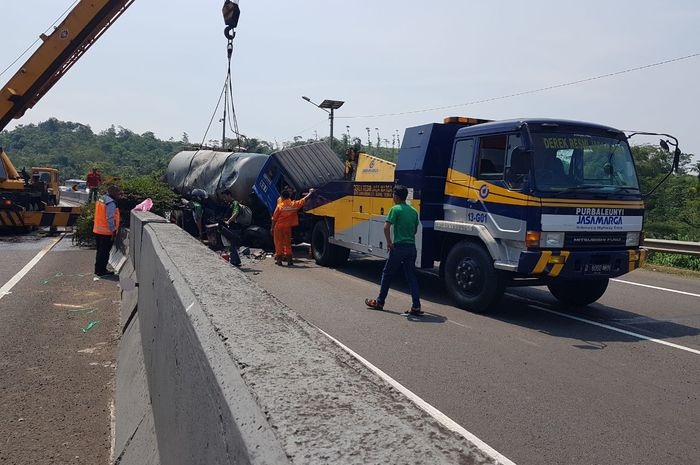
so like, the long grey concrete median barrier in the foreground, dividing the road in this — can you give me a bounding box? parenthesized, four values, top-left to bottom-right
(114, 213, 498, 465)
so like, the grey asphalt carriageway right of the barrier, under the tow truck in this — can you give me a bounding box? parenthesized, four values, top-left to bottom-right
(245, 250, 700, 465)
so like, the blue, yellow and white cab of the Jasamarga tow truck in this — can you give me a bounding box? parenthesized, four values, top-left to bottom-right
(434, 119, 645, 311)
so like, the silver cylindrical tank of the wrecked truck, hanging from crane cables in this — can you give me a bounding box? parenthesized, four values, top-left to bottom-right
(165, 150, 269, 204)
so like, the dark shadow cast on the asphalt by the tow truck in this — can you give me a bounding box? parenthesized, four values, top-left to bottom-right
(326, 252, 700, 350)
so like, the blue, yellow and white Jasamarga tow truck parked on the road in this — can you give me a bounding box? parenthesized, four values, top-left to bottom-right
(304, 117, 681, 312)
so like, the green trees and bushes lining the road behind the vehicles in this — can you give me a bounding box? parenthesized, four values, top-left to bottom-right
(0, 118, 700, 271)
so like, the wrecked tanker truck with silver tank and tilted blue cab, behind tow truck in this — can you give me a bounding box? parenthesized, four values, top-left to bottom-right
(166, 142, 344, 248)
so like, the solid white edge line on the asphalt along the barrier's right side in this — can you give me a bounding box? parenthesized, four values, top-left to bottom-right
(314, 325, 515, 465)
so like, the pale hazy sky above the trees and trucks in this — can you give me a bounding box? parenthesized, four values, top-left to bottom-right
(0, 0, 700, 160)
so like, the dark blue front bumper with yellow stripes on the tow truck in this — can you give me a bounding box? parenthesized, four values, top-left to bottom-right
(518, 248, 646, 279)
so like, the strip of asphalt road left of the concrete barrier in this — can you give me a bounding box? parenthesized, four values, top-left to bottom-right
(0, 235, 119, 465)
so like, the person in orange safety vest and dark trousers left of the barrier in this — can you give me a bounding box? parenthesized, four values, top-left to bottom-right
(92, 186, 122, 277)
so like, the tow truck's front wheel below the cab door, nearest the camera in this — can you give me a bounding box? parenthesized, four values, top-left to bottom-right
(445, 241, 504, 313)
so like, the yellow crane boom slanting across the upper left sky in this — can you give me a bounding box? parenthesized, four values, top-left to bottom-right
(0, 0, 135, 131)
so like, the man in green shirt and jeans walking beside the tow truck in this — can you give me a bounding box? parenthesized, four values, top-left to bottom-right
(365, 185, 423, 315)
